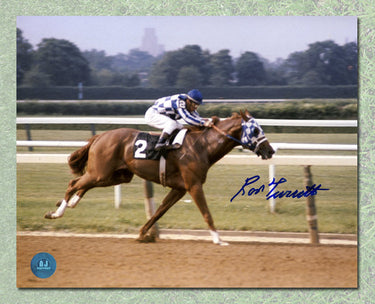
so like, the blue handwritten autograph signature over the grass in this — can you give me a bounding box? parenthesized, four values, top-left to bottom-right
(230, 175, 329, 202)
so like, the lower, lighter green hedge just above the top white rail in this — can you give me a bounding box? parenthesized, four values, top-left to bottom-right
(17, 99, 357, 119)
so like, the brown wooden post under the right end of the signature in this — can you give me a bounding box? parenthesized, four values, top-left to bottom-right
(304, 166, 319, 244)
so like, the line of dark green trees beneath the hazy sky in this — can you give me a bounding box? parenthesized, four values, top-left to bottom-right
(17, 29, 358, 88)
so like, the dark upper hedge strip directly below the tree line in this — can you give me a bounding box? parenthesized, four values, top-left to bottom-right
(17, 86, 358, 100)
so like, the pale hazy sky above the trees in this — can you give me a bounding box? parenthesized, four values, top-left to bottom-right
(17, 16, 357, 61)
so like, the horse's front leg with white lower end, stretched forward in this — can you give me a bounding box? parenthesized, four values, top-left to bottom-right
(189, 184, 229, 246)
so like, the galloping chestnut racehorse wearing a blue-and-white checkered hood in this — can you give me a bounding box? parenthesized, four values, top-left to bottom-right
(45, 110, 275, 245)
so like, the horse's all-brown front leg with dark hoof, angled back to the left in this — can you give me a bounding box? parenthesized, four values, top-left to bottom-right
(137, 189, 186, 242)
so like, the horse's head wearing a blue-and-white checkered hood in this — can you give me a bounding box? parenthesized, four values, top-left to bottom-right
(240, 110, 275, 159)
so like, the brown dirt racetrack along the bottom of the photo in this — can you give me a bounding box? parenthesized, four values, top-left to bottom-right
(17, 236, 357, 288)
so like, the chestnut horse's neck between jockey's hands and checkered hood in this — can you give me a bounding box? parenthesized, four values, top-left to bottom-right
(206, 119, 241, 165)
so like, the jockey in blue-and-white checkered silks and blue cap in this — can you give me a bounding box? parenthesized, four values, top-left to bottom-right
(145, 89, 213, 151)
